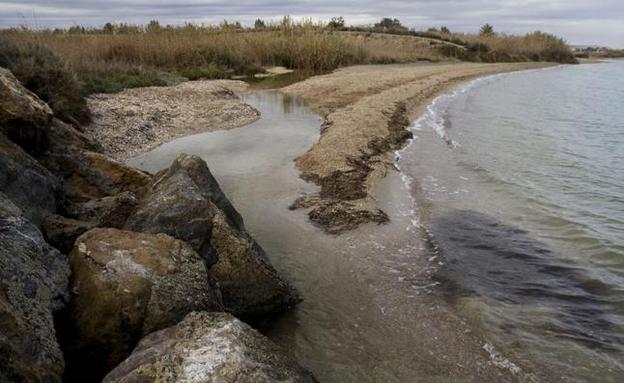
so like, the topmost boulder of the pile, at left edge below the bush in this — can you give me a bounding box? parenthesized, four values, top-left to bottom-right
(0, 68, 53, 153)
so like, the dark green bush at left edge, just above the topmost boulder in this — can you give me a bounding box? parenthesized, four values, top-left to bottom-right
(0, 36, 89, 122)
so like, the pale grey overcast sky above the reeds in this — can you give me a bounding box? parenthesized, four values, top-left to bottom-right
(0, 0, 624, 48)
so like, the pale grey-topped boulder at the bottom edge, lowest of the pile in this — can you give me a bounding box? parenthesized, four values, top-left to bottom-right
(104, 313, 316, 383)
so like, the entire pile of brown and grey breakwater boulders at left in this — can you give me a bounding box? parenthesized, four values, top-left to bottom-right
(0, 68, 314, 382)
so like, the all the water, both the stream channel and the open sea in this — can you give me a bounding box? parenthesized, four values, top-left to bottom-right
(130, 63, 624, 382)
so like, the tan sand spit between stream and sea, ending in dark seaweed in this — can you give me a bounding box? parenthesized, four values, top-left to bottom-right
(283, 63, 551, 233)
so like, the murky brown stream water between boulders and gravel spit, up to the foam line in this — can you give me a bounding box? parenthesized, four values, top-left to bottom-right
(130, 91, 524, 382)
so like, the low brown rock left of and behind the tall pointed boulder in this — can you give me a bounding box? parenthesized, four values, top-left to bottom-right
(40, 148, 151, 202)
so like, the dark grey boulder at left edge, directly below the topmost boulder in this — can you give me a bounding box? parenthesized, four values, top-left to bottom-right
(0, 133, 61, 225)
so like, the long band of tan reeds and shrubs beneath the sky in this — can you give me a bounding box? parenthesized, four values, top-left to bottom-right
(0, 17, 574, 118)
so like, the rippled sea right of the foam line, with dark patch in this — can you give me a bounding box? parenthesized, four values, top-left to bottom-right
(399, 61, 624, 382)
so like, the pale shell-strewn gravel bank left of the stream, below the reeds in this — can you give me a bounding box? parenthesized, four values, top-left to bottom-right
(84, 80, 260, 160)
